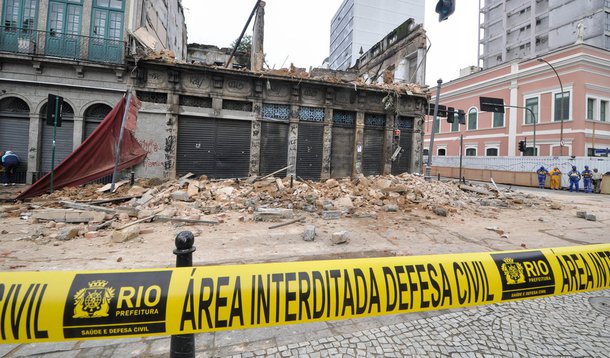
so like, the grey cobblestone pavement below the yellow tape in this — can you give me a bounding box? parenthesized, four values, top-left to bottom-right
(0, 290, 610, 357)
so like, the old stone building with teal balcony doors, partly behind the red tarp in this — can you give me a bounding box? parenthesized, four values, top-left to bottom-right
(0, 0, 186, 182)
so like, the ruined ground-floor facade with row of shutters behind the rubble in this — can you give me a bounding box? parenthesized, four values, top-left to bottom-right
(129, 61, 426, 180)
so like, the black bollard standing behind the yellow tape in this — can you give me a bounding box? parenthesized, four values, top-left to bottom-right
(169, 231, 195, 358)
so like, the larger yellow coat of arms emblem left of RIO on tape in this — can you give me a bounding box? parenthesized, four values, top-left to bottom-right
(72, 280, 114, 318)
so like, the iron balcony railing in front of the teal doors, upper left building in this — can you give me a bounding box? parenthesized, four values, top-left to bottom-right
(0, 27, 126, 64)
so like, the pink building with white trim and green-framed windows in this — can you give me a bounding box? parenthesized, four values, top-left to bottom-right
(424, 44, 610, 156)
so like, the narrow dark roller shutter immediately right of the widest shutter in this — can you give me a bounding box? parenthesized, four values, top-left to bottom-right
(260, 122, 289, 178)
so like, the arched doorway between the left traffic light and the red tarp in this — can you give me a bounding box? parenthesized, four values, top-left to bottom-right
(38, 101, 74, 174)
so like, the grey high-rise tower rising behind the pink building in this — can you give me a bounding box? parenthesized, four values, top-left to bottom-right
(479, 0, 610, 68)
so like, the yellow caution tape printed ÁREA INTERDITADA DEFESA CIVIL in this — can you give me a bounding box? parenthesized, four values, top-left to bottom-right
(0, 244, 610, 343)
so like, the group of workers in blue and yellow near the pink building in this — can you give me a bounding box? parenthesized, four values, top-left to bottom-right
(536, 165, 603, 193)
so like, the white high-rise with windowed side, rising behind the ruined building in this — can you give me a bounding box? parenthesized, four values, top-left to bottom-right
(328, 0, 425, 70)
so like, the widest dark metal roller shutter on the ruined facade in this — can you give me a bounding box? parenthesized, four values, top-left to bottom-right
(176, 116, 251, 178)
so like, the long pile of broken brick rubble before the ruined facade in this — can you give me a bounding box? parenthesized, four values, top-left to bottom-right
(0, 174, 539, 242)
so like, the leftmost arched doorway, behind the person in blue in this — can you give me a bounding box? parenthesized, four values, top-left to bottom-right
(0, 97, 30, 183)
